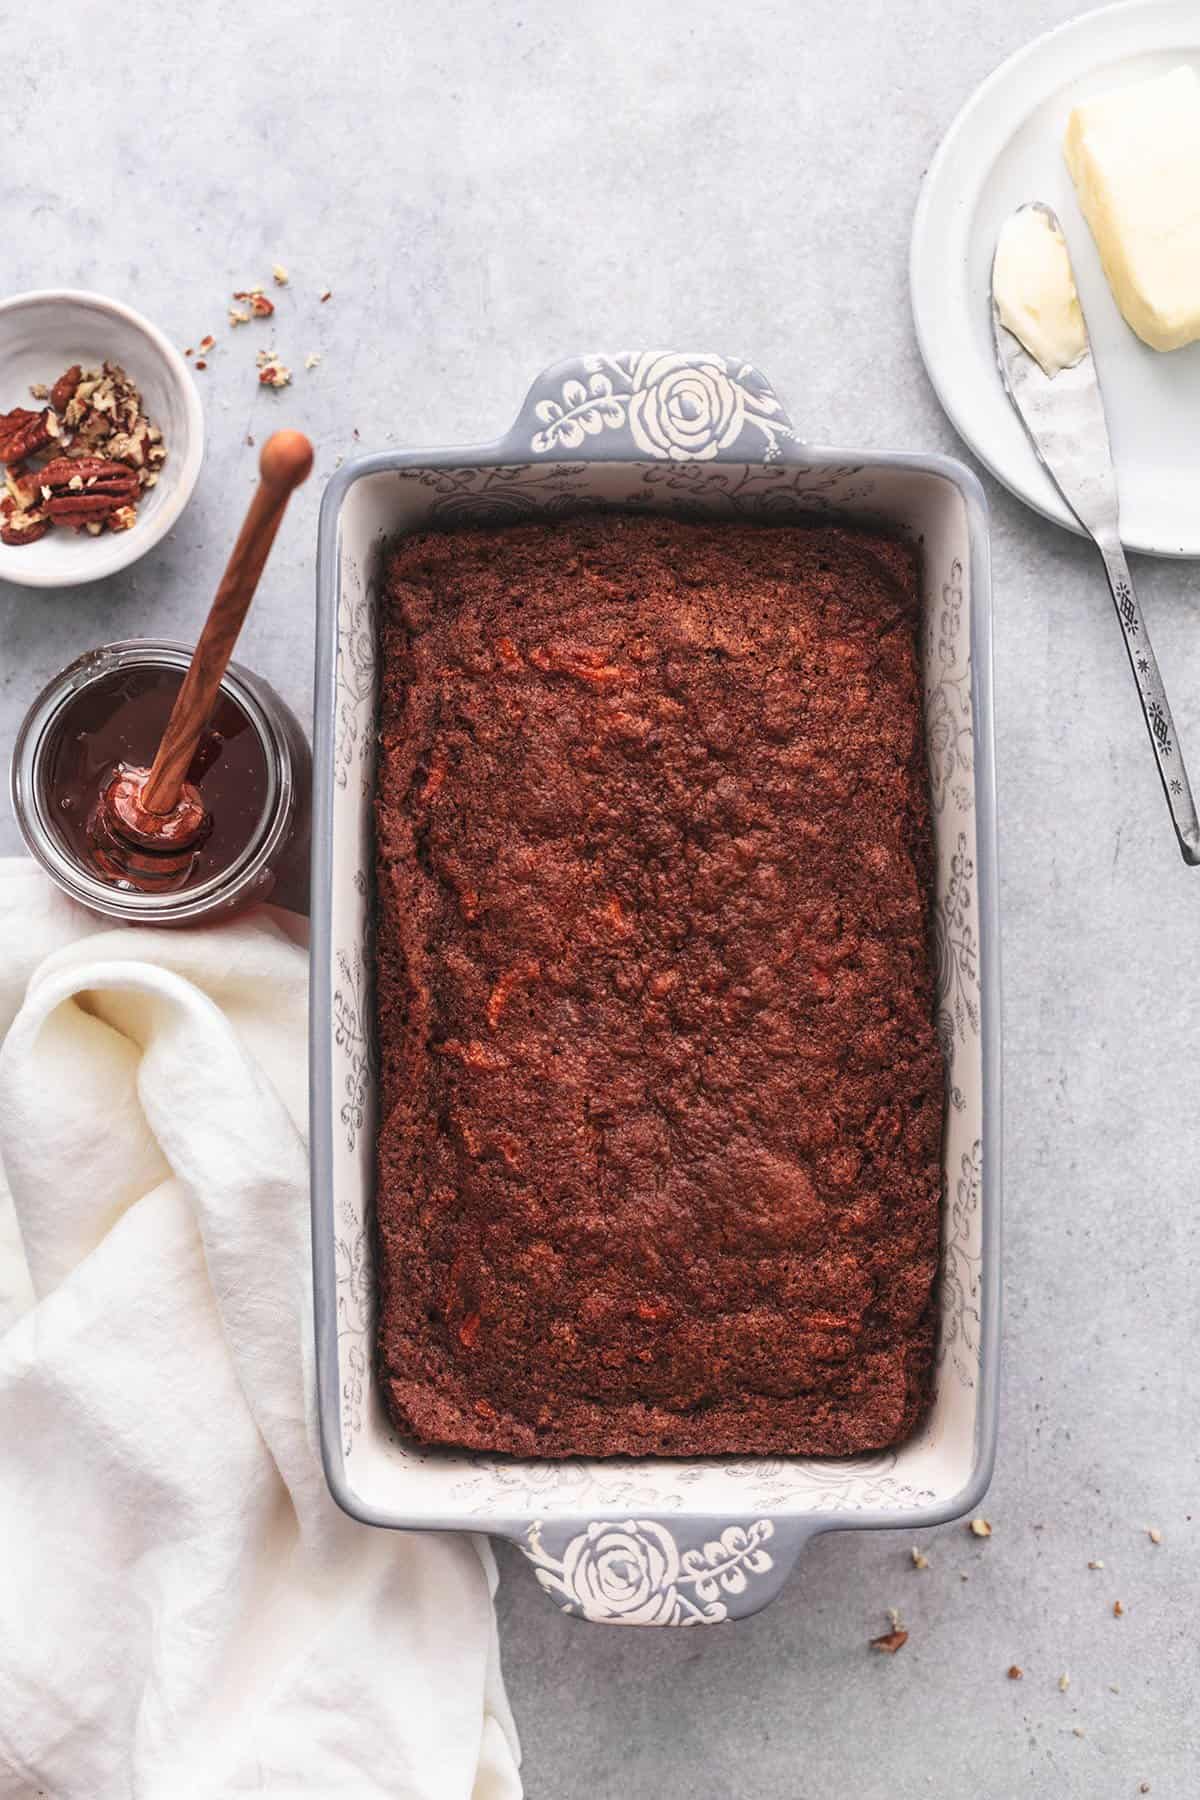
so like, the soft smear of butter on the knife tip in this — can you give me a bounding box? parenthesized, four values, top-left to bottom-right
(991, 207, 1087, 376)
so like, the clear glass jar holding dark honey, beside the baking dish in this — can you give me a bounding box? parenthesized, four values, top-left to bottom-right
(11, 637, 311, 925)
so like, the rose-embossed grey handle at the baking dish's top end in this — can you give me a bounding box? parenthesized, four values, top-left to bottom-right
(504, 349, 797, 464)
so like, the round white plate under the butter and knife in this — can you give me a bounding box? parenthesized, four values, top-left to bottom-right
(910, 0, 1200, 556)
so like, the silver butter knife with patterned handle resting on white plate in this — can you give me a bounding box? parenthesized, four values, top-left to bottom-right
(991, 200, 1200, 868)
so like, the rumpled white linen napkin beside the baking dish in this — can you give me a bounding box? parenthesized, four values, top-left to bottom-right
(0, 860, 522, 1800)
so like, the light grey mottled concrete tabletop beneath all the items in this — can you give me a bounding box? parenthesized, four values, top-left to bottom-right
(0, 0, 1200, 1800)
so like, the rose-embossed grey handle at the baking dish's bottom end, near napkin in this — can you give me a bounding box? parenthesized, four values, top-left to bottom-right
(516, 1517, 815, 1625)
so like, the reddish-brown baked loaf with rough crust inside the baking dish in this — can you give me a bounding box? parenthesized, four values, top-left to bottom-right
(376, 517, 943, 1456)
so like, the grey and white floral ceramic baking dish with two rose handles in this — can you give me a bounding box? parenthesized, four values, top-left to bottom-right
(311, 351, 1000, 1625)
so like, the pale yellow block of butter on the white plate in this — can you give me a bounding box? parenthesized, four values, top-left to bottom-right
(1063, 67, 1200, 349)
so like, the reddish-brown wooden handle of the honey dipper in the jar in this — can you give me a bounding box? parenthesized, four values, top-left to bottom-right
(142, 432, 313, 814)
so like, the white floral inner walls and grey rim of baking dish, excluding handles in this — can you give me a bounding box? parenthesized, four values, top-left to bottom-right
(315, 454, 986, 1530)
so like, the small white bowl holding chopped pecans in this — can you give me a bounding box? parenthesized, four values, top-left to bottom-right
(0, 288, 203, 587)
